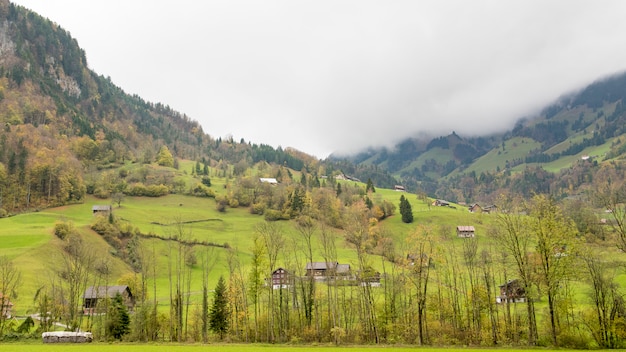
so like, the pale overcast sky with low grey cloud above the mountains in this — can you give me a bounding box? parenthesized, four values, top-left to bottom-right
(13, 0, 626, 158)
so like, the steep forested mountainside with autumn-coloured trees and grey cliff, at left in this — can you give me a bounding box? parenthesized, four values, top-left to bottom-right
(0, 0, 332, 214)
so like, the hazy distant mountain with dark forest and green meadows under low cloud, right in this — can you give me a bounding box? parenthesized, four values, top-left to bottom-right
(331, 73, 626, 202)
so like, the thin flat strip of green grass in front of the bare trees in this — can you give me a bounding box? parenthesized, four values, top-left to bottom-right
(0, 343, 588, 352)
